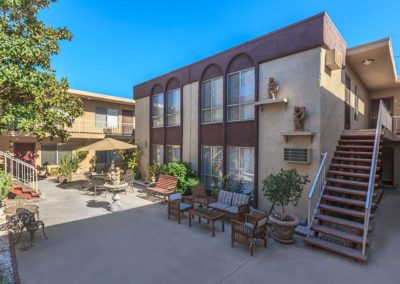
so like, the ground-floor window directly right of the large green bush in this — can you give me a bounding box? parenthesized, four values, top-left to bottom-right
(201, 146, 223, 190)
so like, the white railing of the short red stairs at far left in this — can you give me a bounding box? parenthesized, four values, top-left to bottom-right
(0, 151, 39, 193)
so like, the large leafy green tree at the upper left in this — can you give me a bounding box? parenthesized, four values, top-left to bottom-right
(0, 0, 83, 140)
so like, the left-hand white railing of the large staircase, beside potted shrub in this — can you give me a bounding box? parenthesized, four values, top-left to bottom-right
(307, 152, 328, 237)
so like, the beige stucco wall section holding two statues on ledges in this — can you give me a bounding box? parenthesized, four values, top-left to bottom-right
(258, 48, 321, 219)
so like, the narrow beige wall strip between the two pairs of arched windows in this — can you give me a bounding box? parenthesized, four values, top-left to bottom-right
(182, 82, 199, 171)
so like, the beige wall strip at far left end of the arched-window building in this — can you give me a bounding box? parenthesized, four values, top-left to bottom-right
(135, 97, 150, 174)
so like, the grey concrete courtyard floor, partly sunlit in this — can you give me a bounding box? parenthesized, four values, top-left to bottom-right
(16, 181, 400, 284)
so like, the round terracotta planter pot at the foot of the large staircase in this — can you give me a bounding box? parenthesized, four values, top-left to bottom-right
(269, 214, 300, 244)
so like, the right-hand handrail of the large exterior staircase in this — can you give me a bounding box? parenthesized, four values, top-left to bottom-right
(362, 100, 392, 256)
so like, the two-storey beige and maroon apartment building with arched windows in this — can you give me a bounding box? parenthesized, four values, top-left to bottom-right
(134, 13, 400, 218)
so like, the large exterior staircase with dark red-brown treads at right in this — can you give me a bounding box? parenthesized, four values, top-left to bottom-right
(305, 131, 383, 261)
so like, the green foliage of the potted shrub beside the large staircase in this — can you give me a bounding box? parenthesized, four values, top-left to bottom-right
(263, 169, 310, 220)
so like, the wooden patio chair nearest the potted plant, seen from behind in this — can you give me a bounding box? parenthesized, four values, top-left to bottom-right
(231, 213, 268, 256)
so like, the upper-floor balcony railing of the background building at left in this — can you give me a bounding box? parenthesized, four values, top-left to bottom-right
(68, 119, 134, 136)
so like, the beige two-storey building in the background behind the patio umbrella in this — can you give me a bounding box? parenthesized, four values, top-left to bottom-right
(0, 89, 135, 171)
